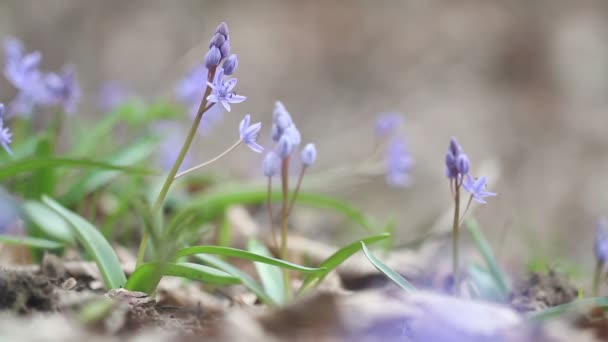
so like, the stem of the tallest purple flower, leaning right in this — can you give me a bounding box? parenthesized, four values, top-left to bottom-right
(135, 68, 216, 267)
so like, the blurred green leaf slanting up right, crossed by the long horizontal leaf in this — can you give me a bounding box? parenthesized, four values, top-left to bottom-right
(61, 137, 159, 205)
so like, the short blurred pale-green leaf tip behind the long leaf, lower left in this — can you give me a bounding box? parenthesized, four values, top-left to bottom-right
(23, 201, 74, 244)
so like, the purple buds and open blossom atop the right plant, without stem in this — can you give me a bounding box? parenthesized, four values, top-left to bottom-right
(445, 137, 496, 203)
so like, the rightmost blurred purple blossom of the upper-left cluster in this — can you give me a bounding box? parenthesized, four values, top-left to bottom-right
(45, 65, 80, 114)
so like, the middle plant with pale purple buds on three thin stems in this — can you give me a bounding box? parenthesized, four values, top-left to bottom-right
(263, 101, 317, 298)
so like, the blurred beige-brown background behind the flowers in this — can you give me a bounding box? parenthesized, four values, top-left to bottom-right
(0, 0, 608, 276)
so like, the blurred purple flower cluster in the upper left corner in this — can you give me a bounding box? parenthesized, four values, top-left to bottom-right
(4, 38, 80, 114)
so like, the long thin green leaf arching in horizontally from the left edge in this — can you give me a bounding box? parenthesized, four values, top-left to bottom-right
(0, 157, 154, 181)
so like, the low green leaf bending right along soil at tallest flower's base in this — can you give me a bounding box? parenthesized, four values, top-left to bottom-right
(125, 262, 241, 293)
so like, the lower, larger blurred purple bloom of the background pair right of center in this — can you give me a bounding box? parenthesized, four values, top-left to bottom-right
(386, 138, 414, 187)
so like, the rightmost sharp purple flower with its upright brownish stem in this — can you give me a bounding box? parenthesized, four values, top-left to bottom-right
(445, 137, 496, 294)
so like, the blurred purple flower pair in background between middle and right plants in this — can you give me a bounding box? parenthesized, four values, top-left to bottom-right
(375, 113, 414, 187)
